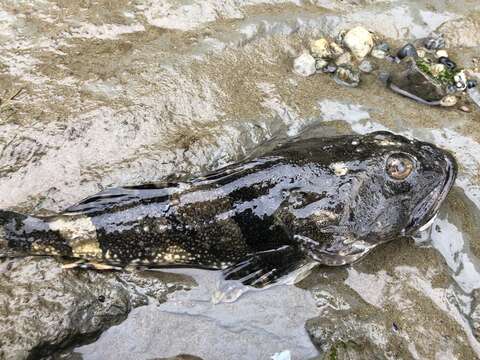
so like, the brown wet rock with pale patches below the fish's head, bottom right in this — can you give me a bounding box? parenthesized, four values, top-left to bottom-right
(301, 238, 476, 360)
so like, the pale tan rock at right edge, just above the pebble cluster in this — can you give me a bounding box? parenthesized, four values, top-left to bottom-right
(437, 17, 480, 47)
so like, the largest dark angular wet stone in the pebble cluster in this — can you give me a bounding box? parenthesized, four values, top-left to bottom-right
(389, 59, 446, 105)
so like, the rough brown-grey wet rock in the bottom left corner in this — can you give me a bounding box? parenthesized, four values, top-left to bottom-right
(0, 258, 191, 359)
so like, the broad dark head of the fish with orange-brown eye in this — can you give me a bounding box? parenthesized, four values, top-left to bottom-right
(347, 131, 457, 242)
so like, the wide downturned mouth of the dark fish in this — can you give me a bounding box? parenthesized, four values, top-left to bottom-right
(403, 152, 457, 235)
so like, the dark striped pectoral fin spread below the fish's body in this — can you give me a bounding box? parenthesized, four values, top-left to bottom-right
(223, 245, 306, 288)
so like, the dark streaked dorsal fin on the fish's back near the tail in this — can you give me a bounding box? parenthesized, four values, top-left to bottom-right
(63, 182, 182, 215)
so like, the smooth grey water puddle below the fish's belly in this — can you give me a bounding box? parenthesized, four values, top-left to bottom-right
(75, 270, 318, 360)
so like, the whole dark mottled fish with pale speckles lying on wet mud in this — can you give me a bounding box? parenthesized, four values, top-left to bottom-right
(0, 131, 457, 287)
